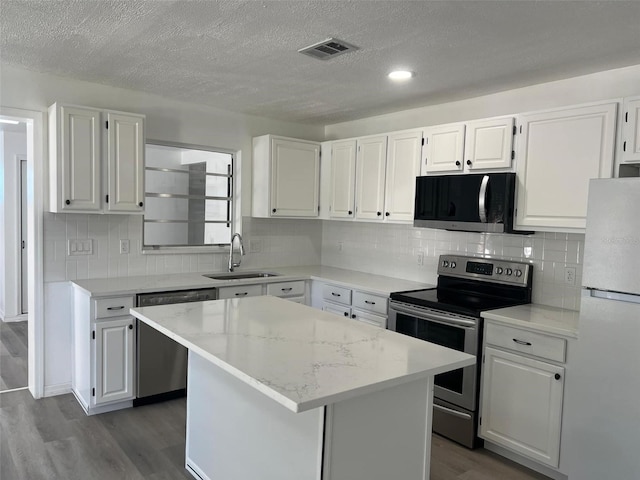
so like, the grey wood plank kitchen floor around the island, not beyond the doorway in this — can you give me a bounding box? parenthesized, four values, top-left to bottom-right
(0, 390, 548, 480)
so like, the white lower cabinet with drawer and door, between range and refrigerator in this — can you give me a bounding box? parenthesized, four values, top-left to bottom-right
(479, 323, 565, 469)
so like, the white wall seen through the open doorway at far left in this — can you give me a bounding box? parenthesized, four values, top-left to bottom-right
(0, 132, 27, 320)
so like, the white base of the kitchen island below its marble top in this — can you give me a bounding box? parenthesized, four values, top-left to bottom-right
(186, 351, 433, 480)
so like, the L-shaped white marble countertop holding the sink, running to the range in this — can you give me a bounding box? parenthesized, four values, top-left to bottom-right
(72, 265, 433, 297)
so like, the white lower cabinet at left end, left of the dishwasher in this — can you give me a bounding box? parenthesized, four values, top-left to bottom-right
(71, 289, 136, 415)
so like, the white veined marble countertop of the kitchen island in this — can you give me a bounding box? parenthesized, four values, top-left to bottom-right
(131, 296, 476, 412)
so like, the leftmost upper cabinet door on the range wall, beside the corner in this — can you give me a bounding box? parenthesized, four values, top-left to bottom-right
(329, 140, 356, 218)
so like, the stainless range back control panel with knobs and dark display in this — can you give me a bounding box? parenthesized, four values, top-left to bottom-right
(438, 255, 532, 286)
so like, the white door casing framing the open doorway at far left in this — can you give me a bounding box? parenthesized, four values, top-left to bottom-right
(0, 106, 48, 398)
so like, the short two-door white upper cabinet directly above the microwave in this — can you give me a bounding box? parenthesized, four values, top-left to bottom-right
(422, 117, 514, 175)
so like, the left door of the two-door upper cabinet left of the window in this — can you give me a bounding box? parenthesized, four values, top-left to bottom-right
(56, 107, 102, 212)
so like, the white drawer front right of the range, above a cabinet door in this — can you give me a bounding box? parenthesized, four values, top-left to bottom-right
(486, 323, 567, 363)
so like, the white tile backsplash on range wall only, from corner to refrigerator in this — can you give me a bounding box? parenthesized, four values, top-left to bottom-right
(322, 221, 584, 310)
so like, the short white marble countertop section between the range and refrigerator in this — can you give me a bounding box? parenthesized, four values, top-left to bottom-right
(482, 303, 580, 338)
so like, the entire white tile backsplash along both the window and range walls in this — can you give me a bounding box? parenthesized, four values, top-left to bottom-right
(44, 213, 584, 310)
